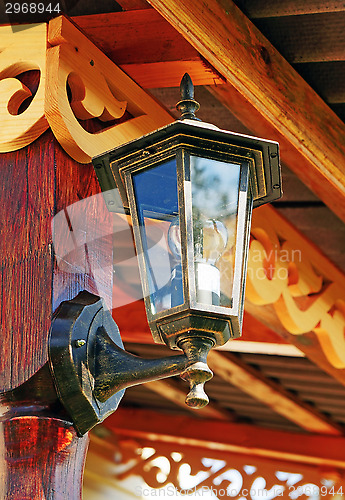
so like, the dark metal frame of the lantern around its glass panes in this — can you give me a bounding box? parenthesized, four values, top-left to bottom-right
(93, 119, 281, 348)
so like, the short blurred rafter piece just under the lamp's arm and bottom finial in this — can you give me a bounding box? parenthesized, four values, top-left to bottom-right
(145, 380, 234, 421)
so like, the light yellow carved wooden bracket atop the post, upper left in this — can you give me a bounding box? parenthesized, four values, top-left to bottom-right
(0, 17, 172, 163)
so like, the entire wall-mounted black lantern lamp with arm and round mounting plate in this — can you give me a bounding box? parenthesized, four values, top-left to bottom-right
(50, 74, 281, 434)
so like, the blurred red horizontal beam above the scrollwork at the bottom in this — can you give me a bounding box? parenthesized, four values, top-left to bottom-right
(104, 408, 345, 469)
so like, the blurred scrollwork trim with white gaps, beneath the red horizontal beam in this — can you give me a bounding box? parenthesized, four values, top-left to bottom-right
(111, 441, 345, 500)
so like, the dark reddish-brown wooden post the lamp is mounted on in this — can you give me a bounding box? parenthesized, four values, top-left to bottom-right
(0, 122, 112, 500)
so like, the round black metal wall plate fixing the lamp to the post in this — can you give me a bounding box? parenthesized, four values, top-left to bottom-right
(49, 291, 124, 435)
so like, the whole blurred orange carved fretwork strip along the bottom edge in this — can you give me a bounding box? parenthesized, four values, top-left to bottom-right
(86, 428, 345, 500)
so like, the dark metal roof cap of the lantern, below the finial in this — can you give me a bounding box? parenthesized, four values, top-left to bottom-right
(93, 118, 282, 208)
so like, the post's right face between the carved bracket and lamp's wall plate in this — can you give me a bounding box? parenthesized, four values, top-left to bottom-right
(53, 127, 113, 310)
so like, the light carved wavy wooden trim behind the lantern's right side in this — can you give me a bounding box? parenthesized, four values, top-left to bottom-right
(246, 206, 345, 385)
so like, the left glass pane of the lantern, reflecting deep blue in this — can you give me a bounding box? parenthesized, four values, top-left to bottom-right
(133, 158, 183, 314)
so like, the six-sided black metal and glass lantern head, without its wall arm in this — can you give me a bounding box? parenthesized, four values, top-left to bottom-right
(93, 74, 281, 396)
